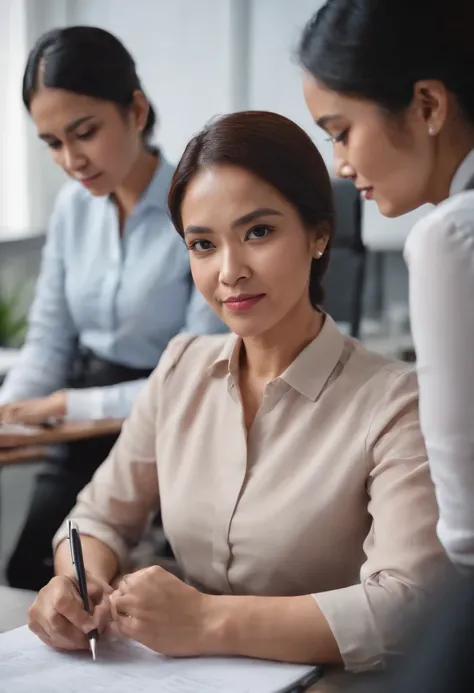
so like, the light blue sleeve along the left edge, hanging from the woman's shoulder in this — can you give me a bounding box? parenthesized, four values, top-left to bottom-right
(0, 193, 77, 404)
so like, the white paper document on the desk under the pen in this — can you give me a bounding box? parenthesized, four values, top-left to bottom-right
(0, 626, 322, 693)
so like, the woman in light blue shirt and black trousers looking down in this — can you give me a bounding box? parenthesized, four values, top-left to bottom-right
(0, 27, 224, 589)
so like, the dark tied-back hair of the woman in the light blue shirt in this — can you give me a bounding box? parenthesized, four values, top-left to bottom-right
(23, 26, 156, 140)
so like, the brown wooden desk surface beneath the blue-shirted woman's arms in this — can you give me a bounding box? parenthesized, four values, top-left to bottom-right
(0, 419, 123, 450)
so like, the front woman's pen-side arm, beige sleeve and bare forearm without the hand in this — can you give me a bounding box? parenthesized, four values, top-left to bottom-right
(54, 369, 160, 582)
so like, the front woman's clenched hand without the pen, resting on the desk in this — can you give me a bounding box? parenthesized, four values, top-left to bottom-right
(110, 566, 212, 657)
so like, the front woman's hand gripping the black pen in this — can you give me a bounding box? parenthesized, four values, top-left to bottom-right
(28, 574, 113, 650)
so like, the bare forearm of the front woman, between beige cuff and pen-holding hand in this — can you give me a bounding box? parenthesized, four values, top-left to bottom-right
(54, 534, 119, 584)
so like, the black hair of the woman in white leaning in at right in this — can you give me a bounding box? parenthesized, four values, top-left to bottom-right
(298, 0, 474, 124)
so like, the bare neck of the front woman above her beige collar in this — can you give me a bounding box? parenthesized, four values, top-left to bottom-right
(241, 301, 324, 382)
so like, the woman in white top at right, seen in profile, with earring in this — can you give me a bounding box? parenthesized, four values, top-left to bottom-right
(299, 0, 474, 566)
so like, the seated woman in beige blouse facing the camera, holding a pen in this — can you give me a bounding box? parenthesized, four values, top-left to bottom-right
(29, 112, 446, 670)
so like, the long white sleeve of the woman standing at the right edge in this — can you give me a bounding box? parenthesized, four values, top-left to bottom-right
(405, 210, 474, 567)
